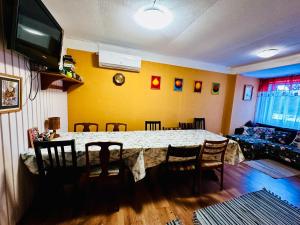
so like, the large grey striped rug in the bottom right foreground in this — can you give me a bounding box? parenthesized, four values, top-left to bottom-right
(193, 189, 300, 225)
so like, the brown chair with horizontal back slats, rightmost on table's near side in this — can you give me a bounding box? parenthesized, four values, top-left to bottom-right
(200, 139, 229, 190)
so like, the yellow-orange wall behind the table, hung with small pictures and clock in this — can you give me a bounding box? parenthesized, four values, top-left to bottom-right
(68, 49, 236, 133)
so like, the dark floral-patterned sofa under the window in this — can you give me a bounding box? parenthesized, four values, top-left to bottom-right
(227, 122, 300, 168)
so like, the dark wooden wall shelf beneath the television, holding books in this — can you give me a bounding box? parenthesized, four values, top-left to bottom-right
(41, 72, 83, 91)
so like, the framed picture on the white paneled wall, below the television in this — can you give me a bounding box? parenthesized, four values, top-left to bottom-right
(0, 74, 22, 113)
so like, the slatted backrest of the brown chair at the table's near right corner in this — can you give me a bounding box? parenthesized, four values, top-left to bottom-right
(200, 139, 229, 163)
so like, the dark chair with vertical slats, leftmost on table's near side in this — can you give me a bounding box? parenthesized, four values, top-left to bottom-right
(34, 140, 83, 207)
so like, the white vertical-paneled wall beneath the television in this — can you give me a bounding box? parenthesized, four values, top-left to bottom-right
(0, 1, 68, 225)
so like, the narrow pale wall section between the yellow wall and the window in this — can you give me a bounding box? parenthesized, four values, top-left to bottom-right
(229, 75, 259, 133)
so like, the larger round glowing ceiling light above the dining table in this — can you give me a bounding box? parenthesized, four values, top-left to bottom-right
(134, 5, 173, 30)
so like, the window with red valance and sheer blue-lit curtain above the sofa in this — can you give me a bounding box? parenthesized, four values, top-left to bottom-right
(255, 76, 300, 130)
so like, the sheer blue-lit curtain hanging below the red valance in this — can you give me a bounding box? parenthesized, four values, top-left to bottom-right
(255, 88, 300, 130)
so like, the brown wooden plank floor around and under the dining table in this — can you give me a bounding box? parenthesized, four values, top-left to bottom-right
(21, 163, 300, 225)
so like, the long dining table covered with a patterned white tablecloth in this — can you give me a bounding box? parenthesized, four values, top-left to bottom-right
(21, 129, 245, 182)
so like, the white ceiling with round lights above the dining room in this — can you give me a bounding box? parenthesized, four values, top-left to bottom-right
(43, 0, 300, 67)
